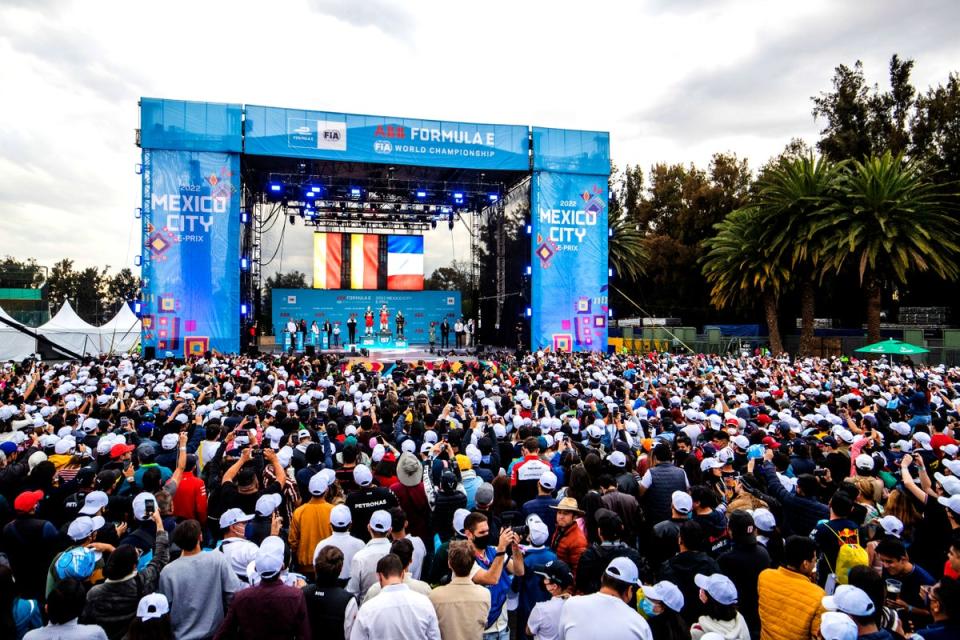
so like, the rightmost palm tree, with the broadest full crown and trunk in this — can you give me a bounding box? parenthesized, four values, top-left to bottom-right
(814, 151, 960, 342)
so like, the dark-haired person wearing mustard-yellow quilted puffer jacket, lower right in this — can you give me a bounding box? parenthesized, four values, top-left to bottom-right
(757, 536, 826, 640)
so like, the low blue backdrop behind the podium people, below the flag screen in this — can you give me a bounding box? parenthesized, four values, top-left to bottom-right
(270, 289, 461, 345)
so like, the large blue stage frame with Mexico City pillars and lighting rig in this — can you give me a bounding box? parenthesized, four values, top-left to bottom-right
(137, 98, 610, 357)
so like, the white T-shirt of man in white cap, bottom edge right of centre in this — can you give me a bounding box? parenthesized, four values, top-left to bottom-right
(560, 592, 653, 640)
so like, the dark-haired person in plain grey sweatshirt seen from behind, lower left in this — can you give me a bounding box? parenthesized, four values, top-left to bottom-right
(159, 520, 243, 640)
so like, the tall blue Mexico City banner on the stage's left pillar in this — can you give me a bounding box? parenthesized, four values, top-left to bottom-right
(141, 149, 240, 357)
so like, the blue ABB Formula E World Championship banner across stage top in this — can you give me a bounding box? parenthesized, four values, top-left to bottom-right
(244, 105, 530, 171)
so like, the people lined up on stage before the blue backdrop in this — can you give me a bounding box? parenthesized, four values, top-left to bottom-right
(285, 305, 476, 351)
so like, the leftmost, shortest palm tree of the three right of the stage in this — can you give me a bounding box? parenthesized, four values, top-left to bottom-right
(701, 207, 790, 354)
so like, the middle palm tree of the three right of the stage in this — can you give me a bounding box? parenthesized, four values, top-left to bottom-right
(750, 154, 842, 355)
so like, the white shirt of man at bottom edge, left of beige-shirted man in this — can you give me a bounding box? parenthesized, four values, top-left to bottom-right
(350, 584, 440, 640)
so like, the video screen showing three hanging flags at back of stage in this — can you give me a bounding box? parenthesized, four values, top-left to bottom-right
(313, 233, 423, 291)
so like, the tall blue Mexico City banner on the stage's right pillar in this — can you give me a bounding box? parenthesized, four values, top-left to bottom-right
(530, 172, 608, 351)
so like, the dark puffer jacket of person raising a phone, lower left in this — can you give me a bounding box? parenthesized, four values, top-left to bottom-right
(80, 531, 170, 640)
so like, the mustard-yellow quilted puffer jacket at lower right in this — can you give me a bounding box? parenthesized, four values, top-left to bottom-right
(757, 567, 826, 640)
